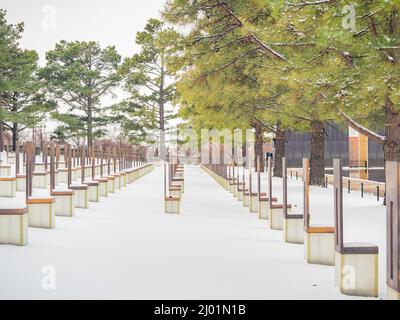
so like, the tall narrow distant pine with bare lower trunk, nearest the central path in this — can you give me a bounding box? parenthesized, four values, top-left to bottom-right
(119, 19, 180, 159)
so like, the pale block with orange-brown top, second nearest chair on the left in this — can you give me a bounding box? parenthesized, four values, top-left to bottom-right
(27, 197, 56, 229)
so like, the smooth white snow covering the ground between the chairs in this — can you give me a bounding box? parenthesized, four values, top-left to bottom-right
(0, 166, 386, 299)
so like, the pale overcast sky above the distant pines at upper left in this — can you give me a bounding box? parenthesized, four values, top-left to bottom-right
(0, 0, 166, 64)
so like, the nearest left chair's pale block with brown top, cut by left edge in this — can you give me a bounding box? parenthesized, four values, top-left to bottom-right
(0, 207, 29, 246)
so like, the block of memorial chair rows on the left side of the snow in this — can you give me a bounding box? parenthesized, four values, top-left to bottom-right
(0, 142, 154, 246)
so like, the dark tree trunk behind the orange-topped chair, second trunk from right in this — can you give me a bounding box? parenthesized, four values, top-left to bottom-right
(310, 121, 325, 186)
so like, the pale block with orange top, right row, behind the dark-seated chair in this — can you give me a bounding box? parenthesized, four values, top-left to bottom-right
(304, 228, 335, 266)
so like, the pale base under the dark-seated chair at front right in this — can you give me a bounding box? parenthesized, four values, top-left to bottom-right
(335, 248, 378, 297)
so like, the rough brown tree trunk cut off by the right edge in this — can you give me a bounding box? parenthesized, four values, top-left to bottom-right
(383, 98, 400, 162)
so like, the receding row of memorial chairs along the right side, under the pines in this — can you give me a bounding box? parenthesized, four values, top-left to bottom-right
(202, 158, 400, 299)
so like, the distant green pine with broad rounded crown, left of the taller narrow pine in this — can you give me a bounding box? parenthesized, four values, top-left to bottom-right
(41, 41, 121, 145)
